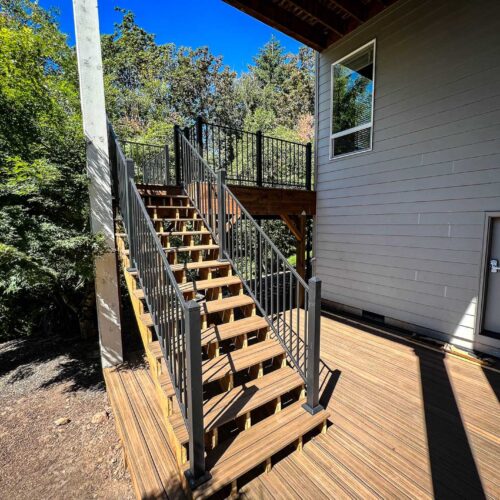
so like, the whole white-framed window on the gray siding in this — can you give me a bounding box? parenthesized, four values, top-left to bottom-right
(330, 40, 375, 158)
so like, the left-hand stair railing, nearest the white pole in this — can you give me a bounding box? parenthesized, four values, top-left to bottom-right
(110, 125, 208, 488)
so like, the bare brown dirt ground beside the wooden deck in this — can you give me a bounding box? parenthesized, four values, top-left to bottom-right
(0, 338, 134, 500)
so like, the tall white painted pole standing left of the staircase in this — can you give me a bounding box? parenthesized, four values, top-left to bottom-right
(73, 0, 123, 368)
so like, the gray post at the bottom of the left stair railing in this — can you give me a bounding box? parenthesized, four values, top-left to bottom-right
(185, 300, 210, 489)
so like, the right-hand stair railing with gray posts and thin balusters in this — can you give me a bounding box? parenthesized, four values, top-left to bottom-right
(177, 130, 321, 413)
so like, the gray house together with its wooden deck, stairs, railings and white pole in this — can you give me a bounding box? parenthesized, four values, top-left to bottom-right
(74, 0, 500, 498)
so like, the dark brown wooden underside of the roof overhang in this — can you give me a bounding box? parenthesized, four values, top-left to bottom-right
(224, 0, 397, 52)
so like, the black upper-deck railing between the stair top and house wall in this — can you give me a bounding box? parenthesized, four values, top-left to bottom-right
(188, 118, 312, 190)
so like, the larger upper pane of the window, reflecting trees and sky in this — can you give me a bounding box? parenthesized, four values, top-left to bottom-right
(332, 45, 374, 134)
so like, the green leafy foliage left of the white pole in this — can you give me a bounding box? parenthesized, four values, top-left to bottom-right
(0, 0, 102, 338)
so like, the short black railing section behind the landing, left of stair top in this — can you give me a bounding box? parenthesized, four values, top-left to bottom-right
(122, 141, 173, 186)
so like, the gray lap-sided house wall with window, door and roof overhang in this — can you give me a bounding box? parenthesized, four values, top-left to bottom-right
(227, 0, 500, 355)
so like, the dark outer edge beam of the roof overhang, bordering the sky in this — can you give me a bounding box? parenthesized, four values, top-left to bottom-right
(224, 0, 328, 52)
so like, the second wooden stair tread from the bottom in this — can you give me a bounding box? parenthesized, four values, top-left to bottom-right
(170, 366, 304, 444)
